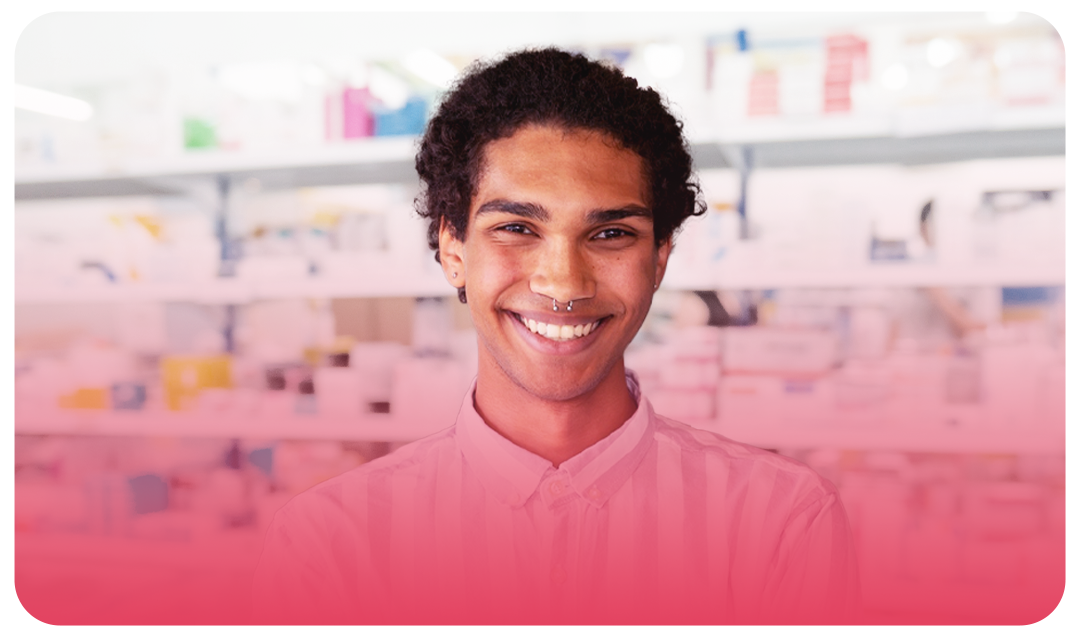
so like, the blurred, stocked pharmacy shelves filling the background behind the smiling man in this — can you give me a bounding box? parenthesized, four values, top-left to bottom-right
(8, 5, 1075, 624)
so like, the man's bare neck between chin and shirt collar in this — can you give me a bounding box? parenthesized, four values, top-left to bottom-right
(474, 359, 637, 467)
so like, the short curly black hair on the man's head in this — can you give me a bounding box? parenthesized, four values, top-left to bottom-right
(416, 49, 705, 260)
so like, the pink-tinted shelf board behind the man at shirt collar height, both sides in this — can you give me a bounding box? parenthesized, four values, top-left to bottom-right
(14, 409, 1065, 454)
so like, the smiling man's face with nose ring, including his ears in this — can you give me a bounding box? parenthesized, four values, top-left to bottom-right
(440, 125, 671, 400)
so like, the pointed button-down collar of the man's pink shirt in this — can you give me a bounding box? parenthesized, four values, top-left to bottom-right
(455, 371, 656, 507)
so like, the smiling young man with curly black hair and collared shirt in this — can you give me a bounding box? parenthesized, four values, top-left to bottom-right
(255, 50, 854, 624)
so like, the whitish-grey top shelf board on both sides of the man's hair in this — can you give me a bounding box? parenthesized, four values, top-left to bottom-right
(14, 126, 1066, 200)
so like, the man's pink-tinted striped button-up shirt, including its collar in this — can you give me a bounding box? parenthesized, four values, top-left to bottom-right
(254, 376, 855, 625)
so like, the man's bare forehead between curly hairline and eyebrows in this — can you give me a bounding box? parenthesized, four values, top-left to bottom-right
(472, 124, 648, 209)
